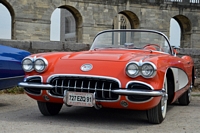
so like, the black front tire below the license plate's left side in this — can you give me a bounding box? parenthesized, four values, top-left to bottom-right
(37, 101, 63, 116)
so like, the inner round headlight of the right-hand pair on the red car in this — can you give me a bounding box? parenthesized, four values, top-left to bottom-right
(126, 63, 139, 78)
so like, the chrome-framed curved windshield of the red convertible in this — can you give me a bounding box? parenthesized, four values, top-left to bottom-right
(91, 30, 171, 53)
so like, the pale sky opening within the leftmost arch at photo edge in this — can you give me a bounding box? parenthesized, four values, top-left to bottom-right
(0, 3, 12, 39)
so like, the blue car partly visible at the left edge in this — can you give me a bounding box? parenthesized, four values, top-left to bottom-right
(0, 45, 30, 90)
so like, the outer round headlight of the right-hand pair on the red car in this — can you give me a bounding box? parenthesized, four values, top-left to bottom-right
(141, 63, 156, 78)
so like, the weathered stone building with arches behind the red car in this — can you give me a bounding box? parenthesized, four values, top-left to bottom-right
(0, 0, 200, 48)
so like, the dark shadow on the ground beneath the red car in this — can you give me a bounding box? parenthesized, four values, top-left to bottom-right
(46, 107, 155, 126)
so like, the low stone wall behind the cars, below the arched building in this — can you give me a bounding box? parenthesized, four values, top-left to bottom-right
(0, 39, 200, 78)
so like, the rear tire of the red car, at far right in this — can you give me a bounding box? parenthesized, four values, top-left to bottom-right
(178, 89, 191, 106)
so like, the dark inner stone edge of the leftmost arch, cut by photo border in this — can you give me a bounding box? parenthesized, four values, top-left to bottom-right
(0, 0, 15, 39)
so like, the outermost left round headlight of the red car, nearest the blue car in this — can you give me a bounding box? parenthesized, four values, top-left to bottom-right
(22, 58, 33, 72)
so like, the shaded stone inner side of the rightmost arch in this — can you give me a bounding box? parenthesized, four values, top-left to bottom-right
(173, 15, 192, 48)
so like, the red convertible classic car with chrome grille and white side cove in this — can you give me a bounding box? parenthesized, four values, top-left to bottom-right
(19, 29, 195, 123)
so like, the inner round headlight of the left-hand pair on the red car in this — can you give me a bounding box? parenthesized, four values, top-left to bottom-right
(34, 58, 48, 72)
